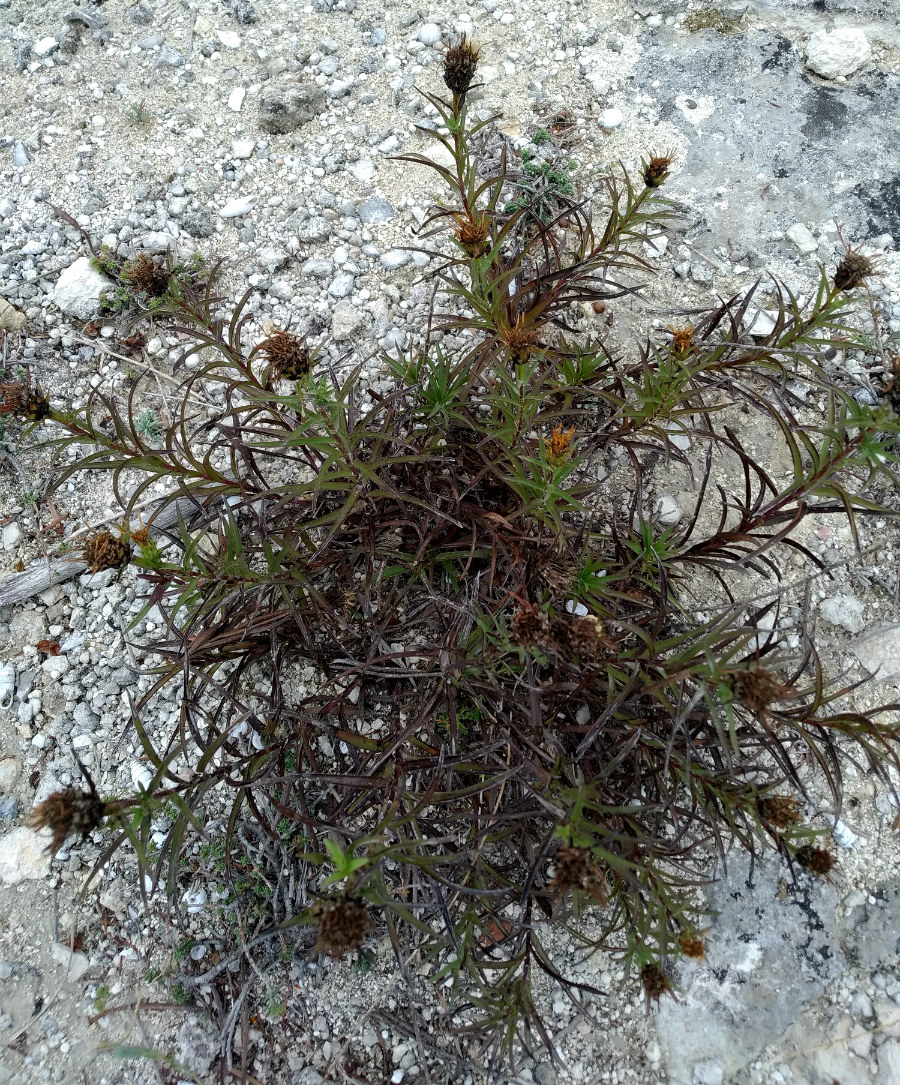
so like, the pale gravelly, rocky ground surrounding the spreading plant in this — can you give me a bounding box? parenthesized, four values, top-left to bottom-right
(0, 0, 900, 1085)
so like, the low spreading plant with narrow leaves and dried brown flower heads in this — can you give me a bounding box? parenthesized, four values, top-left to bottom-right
(12, 42, 900, 1067)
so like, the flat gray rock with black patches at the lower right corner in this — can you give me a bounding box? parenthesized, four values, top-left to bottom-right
(658, 856, 900, 1085)
